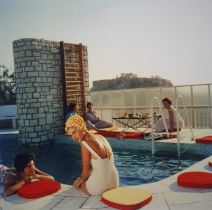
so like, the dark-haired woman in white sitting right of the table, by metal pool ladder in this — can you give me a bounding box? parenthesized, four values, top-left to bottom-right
(155, 98, 184, 132)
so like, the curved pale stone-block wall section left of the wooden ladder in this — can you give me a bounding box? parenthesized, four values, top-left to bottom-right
(13, 39, 63, 143)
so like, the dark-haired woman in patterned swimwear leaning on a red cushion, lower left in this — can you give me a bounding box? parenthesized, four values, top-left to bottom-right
(0, 153, 54, 196)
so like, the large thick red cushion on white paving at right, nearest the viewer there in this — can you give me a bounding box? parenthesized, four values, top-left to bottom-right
(177, 171, 212, 188)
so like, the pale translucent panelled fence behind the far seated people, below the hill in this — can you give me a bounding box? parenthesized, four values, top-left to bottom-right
(90, 84, 212, 128)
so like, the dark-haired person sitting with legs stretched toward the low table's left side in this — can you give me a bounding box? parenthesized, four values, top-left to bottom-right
(85, 102, 113, 130)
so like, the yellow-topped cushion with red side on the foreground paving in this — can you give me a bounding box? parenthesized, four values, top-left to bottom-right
(101, 187, 152, 210)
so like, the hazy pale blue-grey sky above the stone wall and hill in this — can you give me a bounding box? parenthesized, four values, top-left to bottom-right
(0, 0, 212, 85)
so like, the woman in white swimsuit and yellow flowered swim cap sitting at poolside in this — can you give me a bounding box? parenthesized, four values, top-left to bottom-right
(66, 115, 119, 195)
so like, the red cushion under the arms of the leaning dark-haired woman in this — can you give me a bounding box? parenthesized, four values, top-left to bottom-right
(17, 180, 61, 199)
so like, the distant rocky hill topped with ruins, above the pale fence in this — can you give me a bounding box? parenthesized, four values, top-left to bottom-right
(91, 73, 173, 91)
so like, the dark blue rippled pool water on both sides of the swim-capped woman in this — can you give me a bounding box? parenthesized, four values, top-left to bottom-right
(0, 135, 205, 185)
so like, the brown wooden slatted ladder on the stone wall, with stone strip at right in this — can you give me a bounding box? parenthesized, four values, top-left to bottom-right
(60, 42, 89, 119)
